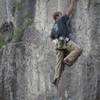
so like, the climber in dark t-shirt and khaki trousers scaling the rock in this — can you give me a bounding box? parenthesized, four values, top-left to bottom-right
(49, 0, 82, 86)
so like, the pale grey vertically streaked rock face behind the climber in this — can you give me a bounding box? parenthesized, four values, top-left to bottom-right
(0, 0, 100, 100)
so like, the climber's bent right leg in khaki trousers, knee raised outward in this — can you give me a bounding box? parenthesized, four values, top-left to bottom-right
(64, 40, 82, 65)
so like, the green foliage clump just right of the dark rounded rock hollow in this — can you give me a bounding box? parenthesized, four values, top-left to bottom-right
(12, 28, 23, 40)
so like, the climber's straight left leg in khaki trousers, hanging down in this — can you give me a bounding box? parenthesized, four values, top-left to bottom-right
(53, 42, 64, 85)
